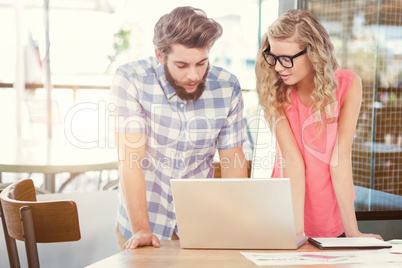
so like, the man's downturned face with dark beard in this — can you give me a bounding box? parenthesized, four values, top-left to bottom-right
(156, 44, 209, 100)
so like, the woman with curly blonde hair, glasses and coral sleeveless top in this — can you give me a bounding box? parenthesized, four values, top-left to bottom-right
(256, 10, 381, 239)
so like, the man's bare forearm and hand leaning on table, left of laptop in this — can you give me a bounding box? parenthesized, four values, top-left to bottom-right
(116, 133, 160, 249)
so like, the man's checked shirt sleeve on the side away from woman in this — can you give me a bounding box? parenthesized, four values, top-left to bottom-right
(109, 66, 145, 133)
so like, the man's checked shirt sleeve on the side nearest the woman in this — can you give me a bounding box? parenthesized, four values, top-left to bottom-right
(217, 81, 247, 150)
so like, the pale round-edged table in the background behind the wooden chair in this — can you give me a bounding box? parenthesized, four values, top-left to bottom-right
(0, 140, 118, 193)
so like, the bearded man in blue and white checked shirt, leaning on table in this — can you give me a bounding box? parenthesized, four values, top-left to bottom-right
(111, 7, 247, 250)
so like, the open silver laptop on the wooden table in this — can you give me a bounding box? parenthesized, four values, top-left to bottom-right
(171, 178, 308, 249)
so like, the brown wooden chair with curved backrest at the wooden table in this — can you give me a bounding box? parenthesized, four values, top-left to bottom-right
(0, 179, 81, 268)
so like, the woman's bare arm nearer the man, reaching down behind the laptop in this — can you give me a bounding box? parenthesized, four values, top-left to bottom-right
(273, 116, 306, 235)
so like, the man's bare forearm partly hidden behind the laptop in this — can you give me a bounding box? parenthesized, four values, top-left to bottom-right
(219, 145, 248, 178)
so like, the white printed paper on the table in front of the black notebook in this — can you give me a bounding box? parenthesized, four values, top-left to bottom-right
(240, 249, 402, 266)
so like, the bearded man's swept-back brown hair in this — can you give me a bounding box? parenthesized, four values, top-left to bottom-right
(153, 7, 223, 56)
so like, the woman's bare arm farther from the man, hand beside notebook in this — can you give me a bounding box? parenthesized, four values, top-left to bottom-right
(330, 76, 381, 239)
